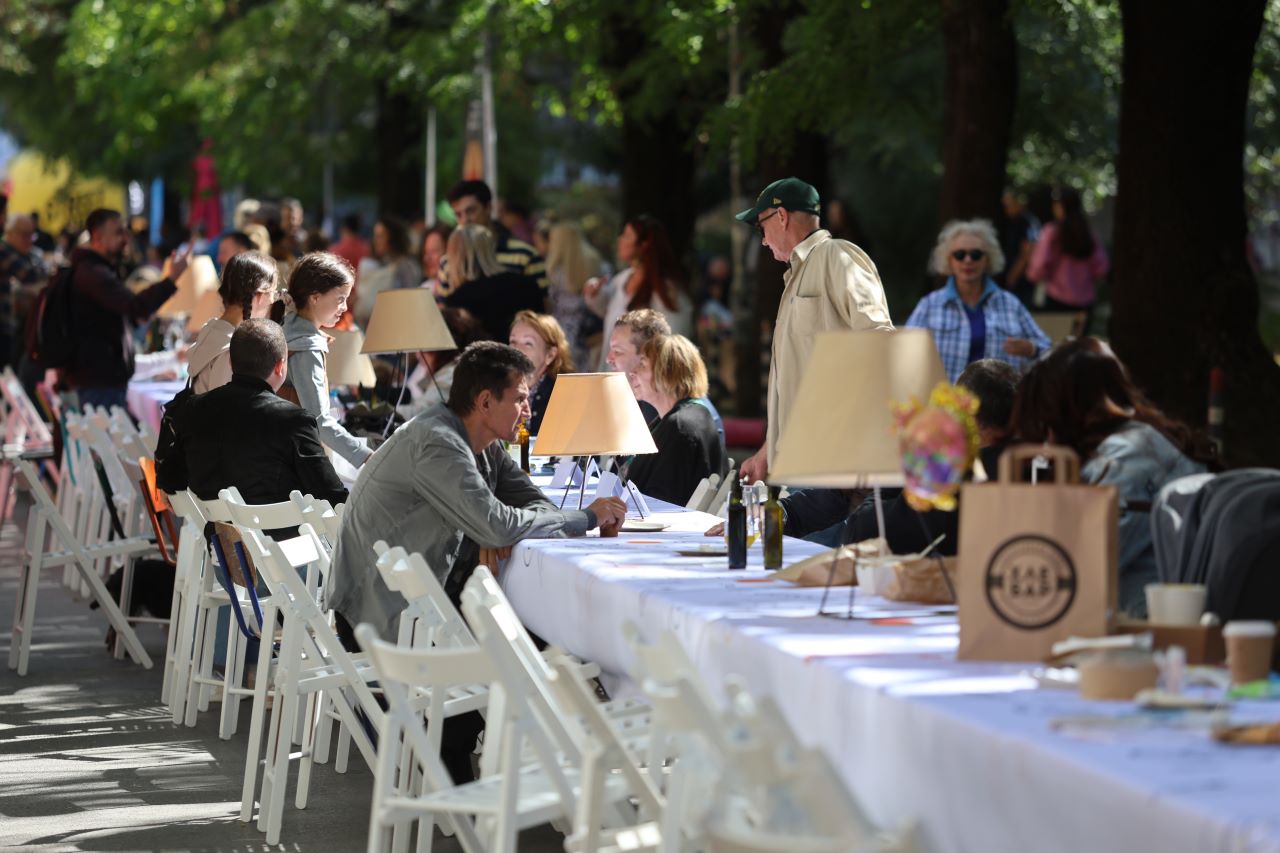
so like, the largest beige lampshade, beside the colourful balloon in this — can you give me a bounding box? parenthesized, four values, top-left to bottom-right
(769, 329, 947, 488)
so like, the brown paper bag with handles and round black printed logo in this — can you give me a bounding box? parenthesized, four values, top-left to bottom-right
(956, 444, 1119, 661)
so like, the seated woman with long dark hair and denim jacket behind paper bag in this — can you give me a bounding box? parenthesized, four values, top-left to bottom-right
(1011, 338, 1216, 616)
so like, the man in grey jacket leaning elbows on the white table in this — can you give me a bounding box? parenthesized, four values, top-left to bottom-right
(329, 341, 626, 638)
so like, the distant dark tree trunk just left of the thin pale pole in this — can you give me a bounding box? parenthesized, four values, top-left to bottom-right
(374, 83, 422, 222)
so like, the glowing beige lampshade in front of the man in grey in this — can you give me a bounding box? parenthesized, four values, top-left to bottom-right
(536, 373, 658, 456)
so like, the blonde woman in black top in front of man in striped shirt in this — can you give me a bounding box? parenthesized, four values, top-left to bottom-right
(444, 224, 545, 341)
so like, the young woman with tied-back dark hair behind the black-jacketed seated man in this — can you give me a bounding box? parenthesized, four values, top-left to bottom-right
(187, 251, 279, 394)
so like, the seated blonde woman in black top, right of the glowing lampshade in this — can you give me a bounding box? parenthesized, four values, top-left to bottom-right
(627, 334, 724, 506)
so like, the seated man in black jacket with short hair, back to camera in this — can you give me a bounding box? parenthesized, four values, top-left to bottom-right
(156, 320, 347, 505)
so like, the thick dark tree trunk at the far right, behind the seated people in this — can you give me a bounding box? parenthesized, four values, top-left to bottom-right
(1110, 0, 1280, 466)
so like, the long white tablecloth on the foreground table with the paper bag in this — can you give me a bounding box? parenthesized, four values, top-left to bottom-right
(502, 484, 1280, 853)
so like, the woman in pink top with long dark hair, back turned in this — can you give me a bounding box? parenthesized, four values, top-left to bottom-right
(1027, 187, 1111, 322)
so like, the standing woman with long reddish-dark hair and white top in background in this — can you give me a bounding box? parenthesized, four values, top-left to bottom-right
(582, 214, 694, 370)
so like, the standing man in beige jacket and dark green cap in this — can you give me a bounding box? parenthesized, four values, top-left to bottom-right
(737, 178, 893, 482)
